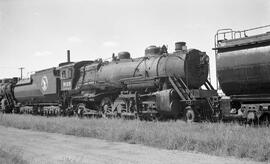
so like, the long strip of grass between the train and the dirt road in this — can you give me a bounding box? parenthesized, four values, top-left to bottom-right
(0, 115, 270, 161)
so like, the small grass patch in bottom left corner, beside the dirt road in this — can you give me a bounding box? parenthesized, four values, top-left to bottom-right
(0, 145, 28, 164)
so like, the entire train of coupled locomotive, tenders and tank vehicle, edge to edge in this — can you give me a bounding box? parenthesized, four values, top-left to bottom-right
(0, 26, 270, 125)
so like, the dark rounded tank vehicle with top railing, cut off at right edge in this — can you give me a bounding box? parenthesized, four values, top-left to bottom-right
(214, 26, 270, 124)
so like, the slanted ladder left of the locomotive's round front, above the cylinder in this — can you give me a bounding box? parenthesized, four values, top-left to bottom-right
(169, 76, 195, 101)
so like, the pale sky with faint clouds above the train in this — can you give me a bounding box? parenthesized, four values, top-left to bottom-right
(0, 0, 270, 88)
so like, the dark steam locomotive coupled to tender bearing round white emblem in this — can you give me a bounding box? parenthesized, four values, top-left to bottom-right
(0, 42, 219, 121)
